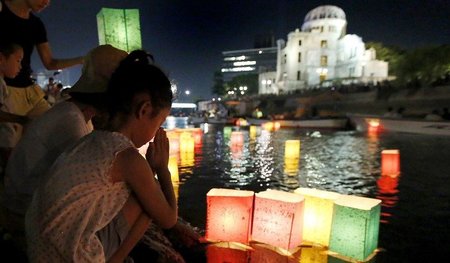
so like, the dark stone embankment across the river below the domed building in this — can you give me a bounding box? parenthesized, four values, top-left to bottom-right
(241, 85, 450, 119)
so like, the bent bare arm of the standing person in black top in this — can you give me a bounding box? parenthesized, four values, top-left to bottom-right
(36, 42, 83, 70)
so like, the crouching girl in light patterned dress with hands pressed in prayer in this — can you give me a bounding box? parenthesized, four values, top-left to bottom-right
(25, 51, 177, 262)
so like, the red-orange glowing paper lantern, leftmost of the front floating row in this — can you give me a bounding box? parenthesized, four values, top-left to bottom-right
(206, 188, 254, 243)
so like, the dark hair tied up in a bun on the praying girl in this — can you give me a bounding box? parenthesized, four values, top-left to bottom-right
(107, 50, 173, 118)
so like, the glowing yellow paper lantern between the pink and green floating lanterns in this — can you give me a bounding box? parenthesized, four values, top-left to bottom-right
(294, 187, 340, 246)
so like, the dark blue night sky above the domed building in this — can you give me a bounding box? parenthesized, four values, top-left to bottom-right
(29, 0, 450, 99)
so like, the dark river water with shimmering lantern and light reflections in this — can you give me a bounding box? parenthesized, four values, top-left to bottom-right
(167, 122, 450, 262)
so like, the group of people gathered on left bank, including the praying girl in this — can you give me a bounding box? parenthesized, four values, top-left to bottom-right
(0, 0, 201, 262)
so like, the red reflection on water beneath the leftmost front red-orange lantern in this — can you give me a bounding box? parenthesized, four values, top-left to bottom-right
(206, 242, 249, 263)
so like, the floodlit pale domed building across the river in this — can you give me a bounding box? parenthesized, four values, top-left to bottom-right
(259, 5, 388, 94)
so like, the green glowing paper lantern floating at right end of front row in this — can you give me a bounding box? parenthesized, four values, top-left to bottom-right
(329, 195, 381, 260)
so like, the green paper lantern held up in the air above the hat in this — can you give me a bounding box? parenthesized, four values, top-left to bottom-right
(97, 8, 142, 52)
